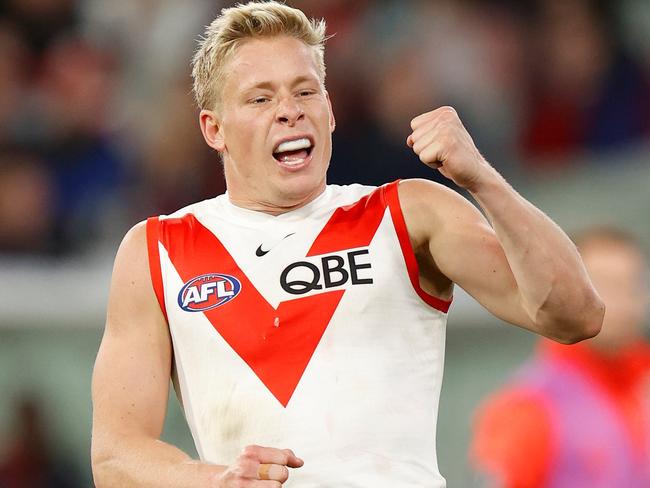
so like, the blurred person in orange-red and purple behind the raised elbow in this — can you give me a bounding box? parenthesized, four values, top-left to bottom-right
(472, 228, 650, 488)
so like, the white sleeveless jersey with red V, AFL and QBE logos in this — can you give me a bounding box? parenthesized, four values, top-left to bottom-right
(147, 182, 450, 488)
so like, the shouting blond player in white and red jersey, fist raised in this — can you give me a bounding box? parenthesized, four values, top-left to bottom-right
(88, 2, 603, 488)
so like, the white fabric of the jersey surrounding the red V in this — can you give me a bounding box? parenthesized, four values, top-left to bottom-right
(155, 185, 446, 488)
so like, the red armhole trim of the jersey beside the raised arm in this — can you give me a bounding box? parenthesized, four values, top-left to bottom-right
(382, 180, 451, 313)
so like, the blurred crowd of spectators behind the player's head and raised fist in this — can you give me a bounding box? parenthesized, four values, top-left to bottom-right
(0, 0, 650, 256)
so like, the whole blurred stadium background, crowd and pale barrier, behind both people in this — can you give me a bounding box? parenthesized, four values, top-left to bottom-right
(0, 0, 650, 487)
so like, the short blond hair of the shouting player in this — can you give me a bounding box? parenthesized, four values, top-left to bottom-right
(192, 1, 326, 109)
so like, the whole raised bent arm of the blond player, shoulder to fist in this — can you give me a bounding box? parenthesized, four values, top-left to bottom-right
(399, 107, 605, 343)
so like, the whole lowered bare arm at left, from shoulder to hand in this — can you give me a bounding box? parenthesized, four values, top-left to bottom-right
(92, 224, 302, 488)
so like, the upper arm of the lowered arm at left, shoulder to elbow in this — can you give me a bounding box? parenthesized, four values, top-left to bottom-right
(93, 226, 171, 442)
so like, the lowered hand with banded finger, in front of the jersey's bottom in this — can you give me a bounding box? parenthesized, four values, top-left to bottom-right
(213, 446, 304, 488)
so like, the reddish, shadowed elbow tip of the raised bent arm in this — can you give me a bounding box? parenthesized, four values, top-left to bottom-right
(542, 292, 605, 345)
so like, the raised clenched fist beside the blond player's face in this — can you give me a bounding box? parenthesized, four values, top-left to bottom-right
(406, 107, 494, 191)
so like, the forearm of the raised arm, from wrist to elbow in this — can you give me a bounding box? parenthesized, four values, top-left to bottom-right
(471, 168, 604, 342)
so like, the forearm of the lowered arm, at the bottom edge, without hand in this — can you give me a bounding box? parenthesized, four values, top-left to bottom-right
(92, 437, 225, 488)
